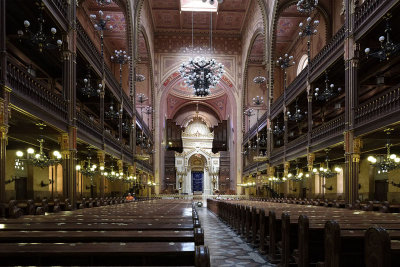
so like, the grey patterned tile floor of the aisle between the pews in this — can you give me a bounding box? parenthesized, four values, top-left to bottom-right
(197, 207, 275, 267)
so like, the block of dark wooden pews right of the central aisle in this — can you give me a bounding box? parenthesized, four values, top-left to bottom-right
(207, 199, 400, 267)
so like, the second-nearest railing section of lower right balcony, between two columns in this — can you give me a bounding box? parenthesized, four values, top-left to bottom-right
(311, 114, 344, 146)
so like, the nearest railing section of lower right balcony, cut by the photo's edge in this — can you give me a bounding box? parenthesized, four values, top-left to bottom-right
(355, 85, 400, 126)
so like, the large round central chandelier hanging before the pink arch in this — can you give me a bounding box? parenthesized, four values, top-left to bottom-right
(179, 57, 225, 96)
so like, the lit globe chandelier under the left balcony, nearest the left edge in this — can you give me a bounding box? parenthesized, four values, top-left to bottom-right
(15, 138, 61, 169)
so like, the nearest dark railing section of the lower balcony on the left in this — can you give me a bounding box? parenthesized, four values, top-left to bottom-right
(7, 57, 67, 120)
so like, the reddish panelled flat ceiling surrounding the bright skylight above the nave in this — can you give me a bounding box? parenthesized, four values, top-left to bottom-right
(150, 0, 250, 33)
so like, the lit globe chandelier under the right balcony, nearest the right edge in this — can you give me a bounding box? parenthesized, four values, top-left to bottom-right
(368, 129, 400, 174)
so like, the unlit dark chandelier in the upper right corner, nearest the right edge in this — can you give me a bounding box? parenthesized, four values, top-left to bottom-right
(364, 14, 400, 61)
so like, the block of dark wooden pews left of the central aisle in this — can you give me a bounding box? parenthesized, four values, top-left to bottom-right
(0, 199, 210, 267)
